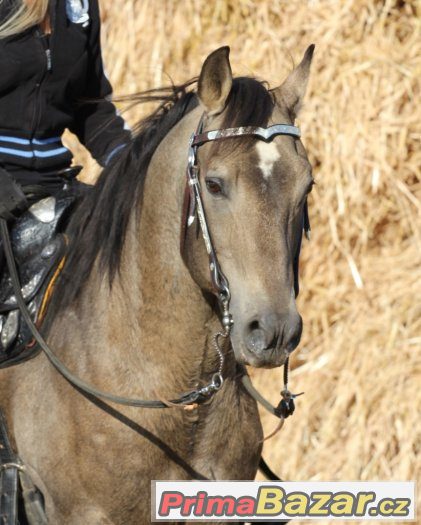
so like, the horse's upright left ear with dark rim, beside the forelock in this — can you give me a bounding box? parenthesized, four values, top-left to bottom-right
(198, 46, 232, 115)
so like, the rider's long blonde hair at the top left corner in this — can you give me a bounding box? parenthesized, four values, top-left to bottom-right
(0, 0, 49, 39)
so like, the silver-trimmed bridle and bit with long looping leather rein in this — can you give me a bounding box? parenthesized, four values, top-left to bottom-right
(0, 111, 300, 418)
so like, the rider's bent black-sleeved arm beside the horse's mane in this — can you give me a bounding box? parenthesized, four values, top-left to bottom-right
(70, 0, 131, 166)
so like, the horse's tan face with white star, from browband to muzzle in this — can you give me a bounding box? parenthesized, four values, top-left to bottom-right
(182, 46, 313, 367)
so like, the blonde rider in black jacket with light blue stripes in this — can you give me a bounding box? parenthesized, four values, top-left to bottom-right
(0, 0, 131, 213)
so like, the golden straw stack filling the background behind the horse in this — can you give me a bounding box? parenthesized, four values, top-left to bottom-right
(68, 0, 421, 523)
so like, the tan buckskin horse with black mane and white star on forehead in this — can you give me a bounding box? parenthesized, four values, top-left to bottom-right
(0, 46, 314, 525)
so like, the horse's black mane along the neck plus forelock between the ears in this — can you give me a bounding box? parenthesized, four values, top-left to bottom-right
(53, 77, 274, 311)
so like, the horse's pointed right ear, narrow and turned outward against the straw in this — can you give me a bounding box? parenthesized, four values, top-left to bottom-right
(273, 44, 315, 117)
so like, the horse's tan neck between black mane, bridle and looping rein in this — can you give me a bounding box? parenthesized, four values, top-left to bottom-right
(55, 106, 218, 395)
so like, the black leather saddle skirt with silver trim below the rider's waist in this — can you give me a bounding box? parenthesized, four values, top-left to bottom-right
(0, 190, 76, 368)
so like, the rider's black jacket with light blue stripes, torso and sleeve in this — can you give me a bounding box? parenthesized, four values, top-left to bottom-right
(0, 0, 130, 170)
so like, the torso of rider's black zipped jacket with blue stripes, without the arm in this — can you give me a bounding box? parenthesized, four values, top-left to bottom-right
(0, 0, 99, 169)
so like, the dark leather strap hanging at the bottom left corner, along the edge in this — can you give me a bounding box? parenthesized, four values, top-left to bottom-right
(0, 410, 21, 525)
